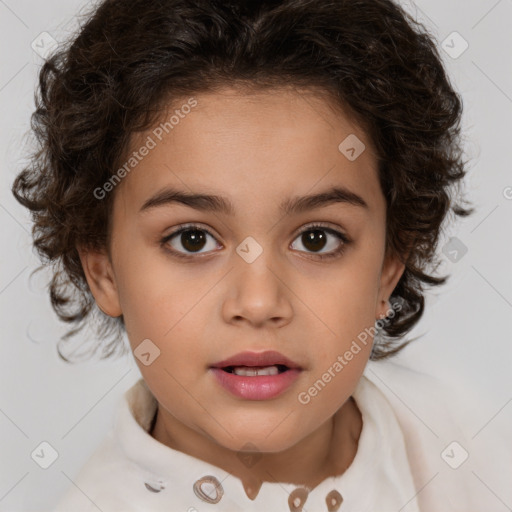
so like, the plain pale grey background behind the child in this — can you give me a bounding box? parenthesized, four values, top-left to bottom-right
(0, 0, 512, 511)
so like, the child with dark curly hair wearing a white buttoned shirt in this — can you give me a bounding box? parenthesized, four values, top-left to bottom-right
(13, 0, 500, 512)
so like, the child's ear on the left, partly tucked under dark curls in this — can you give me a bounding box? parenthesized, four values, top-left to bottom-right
(77, 247, 122, 317)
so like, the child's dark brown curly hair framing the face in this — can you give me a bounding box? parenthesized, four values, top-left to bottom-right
(12, 0, 473, 361)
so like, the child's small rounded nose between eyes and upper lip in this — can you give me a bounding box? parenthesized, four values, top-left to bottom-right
(222, 251, 293, 327)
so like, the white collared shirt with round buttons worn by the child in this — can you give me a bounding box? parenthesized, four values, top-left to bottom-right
(54, 360, 504, 512)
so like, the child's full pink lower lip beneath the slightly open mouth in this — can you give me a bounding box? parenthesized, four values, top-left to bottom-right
(210, 368, 301, 400)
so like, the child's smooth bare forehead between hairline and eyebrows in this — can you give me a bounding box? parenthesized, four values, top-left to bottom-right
(116, 88, 384, 216)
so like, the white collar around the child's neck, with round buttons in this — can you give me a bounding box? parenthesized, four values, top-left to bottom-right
(114, 362, 417, 512)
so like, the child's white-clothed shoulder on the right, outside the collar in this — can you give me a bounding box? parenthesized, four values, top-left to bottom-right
(363, 360, 512, 512)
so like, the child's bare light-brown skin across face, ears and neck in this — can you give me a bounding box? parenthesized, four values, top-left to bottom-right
(79, 87, 404, 499)
